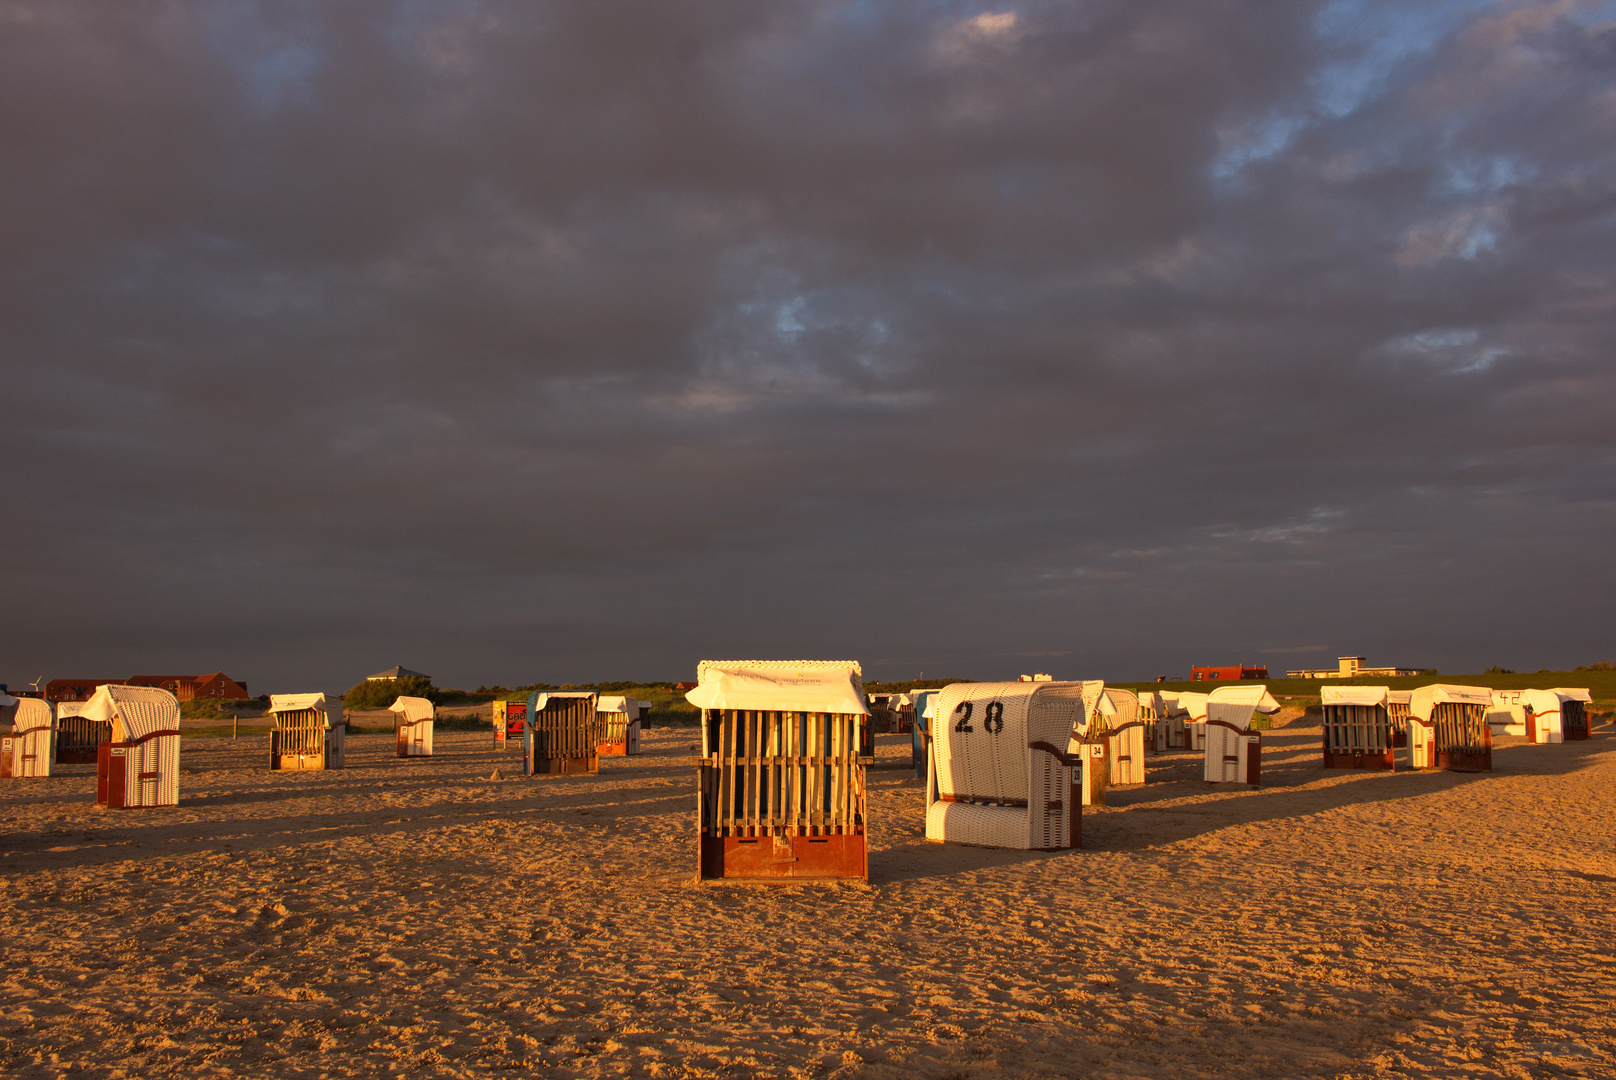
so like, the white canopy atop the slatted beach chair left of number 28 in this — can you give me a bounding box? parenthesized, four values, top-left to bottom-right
(685, 660, 869, 716)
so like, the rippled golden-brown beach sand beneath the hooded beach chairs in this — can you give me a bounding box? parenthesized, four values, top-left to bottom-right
(0, 719, 1616, 1078)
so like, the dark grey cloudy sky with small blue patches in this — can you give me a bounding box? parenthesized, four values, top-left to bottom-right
(0, 0, 1616, 692)
